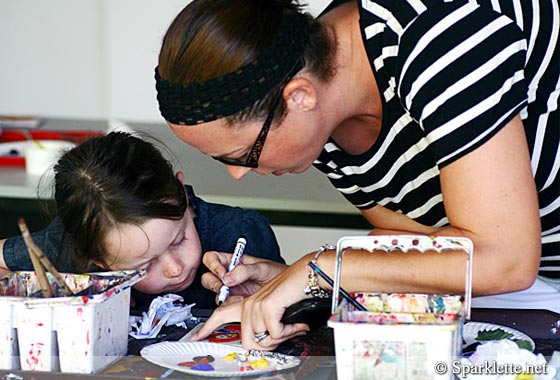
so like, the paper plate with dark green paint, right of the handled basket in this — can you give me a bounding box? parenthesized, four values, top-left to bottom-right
(463, 322, 535, 351)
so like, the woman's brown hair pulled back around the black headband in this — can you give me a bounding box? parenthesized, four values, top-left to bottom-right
(156, 0, 335, 123)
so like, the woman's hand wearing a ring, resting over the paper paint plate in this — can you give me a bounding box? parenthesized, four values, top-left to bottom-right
(193, 255, 311, 350)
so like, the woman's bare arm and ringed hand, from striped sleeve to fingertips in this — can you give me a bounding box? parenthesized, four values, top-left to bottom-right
(197, 117, 540, 349)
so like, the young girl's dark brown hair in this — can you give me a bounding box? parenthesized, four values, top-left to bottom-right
(54, 132, 187, 271)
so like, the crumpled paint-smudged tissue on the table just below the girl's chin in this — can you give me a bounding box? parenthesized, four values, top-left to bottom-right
(128, 294, 195, 339)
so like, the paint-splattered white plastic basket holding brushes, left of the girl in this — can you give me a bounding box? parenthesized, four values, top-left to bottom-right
(0, 270, 145, 373)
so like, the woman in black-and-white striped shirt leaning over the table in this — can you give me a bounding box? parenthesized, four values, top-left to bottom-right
(156, 0, 560, 349)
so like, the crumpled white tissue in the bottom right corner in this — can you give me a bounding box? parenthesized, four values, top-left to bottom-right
(459, 339, 556, 380)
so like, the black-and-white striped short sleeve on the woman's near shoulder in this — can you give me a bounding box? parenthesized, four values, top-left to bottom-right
(397, 2, 527, 167)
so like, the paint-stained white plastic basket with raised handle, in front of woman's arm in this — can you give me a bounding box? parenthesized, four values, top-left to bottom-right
(328, 235, 473, 380)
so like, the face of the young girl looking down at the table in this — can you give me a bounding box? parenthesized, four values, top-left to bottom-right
(101, 209, 202, 294)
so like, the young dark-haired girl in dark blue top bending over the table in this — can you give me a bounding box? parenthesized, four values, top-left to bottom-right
(0, 132, 284, 309)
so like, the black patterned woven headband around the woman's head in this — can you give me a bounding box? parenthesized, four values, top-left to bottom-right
(155, 14, 309, 125)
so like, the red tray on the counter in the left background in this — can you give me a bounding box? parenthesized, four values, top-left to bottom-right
(0, 128, 105, 168)
